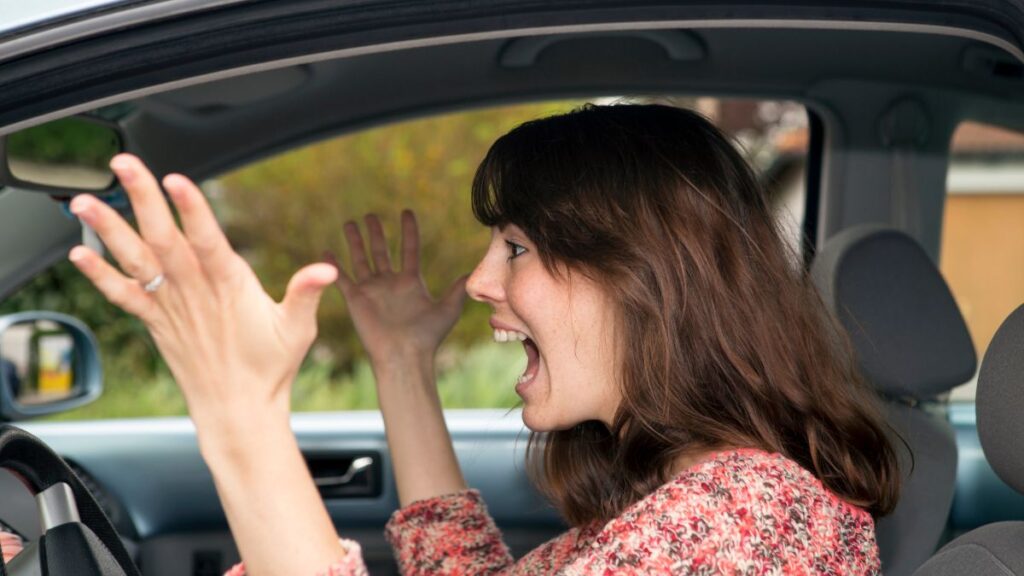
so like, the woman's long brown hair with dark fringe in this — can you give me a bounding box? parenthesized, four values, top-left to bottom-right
(472, 105, 900, 525)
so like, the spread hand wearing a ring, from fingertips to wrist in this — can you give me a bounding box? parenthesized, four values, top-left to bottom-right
(70, 154, 337, 434)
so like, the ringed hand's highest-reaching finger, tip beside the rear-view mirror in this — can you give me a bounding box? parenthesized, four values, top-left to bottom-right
(111, 154, 194, 278)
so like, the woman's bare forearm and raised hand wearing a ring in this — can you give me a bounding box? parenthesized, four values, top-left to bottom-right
(69, 154, 356, 574)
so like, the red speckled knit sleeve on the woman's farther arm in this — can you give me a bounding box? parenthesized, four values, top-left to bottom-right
(385, 490, 513, 576)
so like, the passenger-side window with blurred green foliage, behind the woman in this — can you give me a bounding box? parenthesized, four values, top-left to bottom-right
(4, 97, 807, 419)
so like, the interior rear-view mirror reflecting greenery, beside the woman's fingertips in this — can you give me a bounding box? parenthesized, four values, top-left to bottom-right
(0, 116, 124, 194)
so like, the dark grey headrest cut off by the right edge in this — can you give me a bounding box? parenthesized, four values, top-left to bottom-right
(975, 305, 1024, 492)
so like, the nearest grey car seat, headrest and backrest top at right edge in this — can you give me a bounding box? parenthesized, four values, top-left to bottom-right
(914, 305, 1024, 576)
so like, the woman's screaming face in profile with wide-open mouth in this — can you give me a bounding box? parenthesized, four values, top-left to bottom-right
(466, 224, 621, 431)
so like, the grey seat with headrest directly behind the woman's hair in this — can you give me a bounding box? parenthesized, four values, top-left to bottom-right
(812, 227, 977, 576)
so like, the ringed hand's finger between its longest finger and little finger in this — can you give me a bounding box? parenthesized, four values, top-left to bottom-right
(70, 195, 163, 283)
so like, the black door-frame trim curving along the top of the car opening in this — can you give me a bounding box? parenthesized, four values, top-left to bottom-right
(0, 0, 1024, 126)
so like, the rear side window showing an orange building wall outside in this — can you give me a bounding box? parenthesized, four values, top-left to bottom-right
(939, 122, 1024, 402)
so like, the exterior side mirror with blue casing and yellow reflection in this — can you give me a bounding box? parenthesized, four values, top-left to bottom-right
(0, 312, 102, 421)
